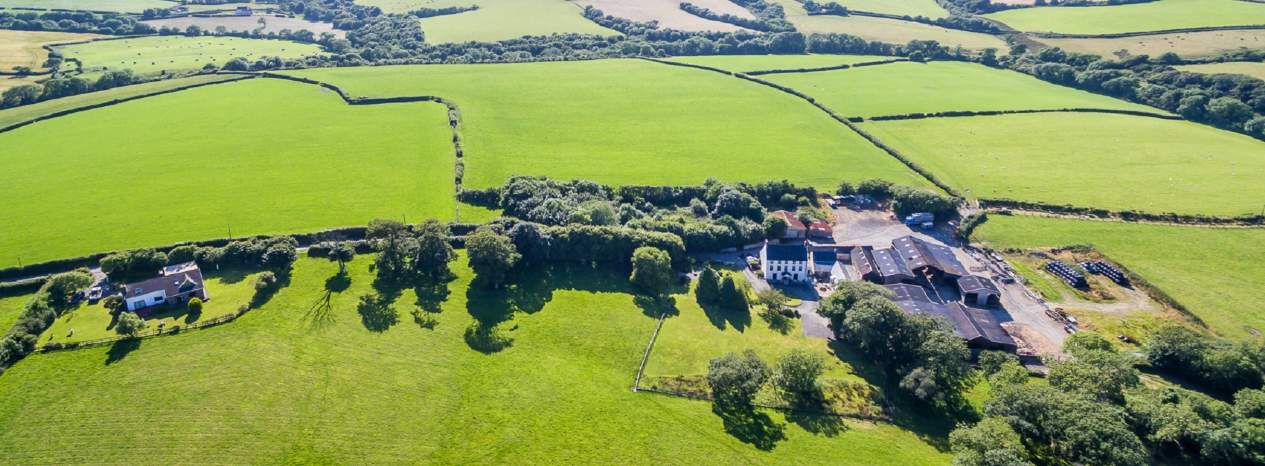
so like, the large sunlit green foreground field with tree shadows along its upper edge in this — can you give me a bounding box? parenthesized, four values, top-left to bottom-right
(0, 257, 949, 465)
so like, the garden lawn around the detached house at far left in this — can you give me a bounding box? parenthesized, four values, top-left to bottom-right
(39, 265, 257, 346)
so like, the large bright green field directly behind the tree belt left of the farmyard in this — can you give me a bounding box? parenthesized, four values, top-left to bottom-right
(287, 60, 921, 189)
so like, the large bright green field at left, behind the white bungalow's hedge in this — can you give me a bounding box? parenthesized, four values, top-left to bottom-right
(0, 80, 455, 266)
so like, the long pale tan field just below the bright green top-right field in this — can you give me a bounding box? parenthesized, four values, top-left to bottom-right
(1039, 29, 1265, 57)
